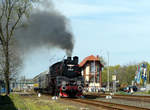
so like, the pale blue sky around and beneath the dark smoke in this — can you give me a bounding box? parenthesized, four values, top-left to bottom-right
(22, 0, 150, 78)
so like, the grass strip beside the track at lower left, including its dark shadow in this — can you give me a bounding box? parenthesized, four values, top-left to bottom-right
(0, 94, 78, 110)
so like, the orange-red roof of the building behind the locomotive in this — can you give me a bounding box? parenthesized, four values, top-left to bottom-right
(79, 55, 100, 67)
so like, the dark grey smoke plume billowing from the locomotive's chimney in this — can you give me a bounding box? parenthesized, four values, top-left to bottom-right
(15, 0, 74, 56)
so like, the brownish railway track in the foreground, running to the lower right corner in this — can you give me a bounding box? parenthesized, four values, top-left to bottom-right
(67, 99, 150, 110)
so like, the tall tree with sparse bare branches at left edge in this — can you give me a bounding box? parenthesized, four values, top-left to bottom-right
(0, 0, 32, 95)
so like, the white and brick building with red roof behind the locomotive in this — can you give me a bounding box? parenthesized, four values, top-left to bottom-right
(80, 55, 103, 91)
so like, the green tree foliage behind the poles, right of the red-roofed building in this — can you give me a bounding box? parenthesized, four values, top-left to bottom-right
(102, 62, 150, 85)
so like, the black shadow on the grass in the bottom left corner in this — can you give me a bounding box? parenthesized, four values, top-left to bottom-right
(0, 95, 17, 110)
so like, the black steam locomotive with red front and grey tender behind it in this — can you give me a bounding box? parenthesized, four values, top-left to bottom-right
(35, 56, 84, 97)
